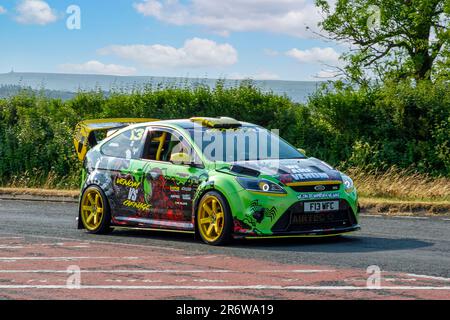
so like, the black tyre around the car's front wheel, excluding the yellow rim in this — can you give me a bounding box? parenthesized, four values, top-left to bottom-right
(196, 191, 234, 246)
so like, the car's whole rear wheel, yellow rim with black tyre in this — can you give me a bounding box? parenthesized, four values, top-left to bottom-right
(80, 186, 112, 234)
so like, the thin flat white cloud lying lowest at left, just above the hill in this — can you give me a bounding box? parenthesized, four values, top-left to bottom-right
(59, 60, 136, 76)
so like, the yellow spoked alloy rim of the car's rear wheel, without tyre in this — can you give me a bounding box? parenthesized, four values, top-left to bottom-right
(81, 189, 105, 231)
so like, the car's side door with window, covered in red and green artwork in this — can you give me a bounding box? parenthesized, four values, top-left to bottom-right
(143, 127, 207, 230)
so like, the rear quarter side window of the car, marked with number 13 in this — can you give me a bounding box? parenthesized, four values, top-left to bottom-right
(102, 128, 145, 159)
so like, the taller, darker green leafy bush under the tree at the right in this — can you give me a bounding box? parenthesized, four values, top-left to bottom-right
(309, 81, 450, 176)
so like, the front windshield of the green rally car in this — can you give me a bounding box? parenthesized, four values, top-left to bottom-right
(188, 126, 306, 162)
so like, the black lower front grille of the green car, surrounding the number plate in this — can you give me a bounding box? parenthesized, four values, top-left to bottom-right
(272, 200, 357, 232)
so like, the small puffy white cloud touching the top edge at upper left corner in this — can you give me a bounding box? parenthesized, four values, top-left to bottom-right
(16, 0, 57, 25)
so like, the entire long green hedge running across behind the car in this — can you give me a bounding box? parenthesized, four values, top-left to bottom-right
(0, 82, 450, 188)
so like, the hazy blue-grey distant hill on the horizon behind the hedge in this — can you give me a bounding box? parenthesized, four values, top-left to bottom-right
(0, 72, 321, 102)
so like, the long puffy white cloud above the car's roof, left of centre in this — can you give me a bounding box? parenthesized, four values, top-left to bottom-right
(99, 38, 238, 68)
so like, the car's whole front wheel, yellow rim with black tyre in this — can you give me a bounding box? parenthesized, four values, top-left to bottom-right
(197, 191, 233, 246)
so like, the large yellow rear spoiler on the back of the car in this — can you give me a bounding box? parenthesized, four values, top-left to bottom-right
(74, 118, 158, 161)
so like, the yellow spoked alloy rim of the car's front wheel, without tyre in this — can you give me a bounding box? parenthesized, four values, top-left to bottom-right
(198, 195, 225, 242)
